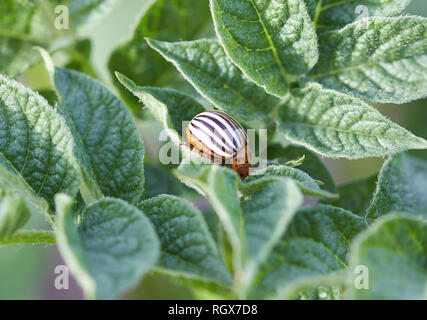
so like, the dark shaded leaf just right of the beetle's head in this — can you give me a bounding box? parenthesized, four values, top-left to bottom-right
(267, 144, 337, 193)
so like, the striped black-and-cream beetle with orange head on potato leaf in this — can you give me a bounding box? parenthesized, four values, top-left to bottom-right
(185, 110, 250, 180)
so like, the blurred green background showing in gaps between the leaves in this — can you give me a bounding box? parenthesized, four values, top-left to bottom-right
(0, 0, 427, 299)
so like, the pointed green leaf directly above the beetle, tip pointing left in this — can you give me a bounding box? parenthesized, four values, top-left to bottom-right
(147, 39, 277, 122)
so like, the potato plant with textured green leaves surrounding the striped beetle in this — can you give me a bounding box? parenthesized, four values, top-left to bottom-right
(0, 0, 427, 299)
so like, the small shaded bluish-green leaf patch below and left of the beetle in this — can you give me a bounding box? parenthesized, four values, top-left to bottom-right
(144, 164, 182, 199)
